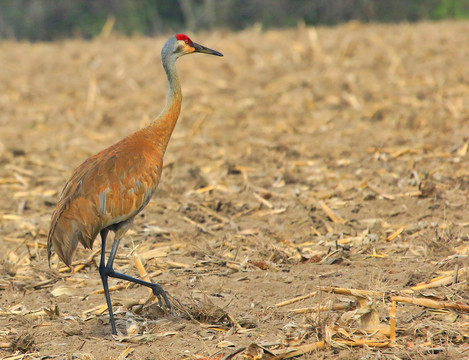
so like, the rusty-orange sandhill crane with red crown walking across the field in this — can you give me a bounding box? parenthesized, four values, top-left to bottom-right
(47, 34, 223, 335)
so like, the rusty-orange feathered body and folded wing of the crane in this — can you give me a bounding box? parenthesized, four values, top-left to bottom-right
(47, 133, 162, 265)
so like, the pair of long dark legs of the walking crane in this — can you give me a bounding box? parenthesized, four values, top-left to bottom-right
(99, 229, 171, 335)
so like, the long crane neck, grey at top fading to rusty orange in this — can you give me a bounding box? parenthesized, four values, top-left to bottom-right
(149, 56, 182, 154)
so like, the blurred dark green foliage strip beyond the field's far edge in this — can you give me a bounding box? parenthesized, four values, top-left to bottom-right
(0, 0, 469, 41)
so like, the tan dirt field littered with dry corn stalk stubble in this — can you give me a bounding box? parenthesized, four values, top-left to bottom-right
(0, 22, 469, 360)
